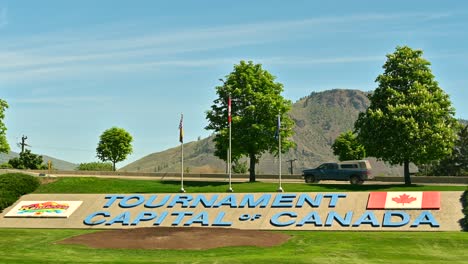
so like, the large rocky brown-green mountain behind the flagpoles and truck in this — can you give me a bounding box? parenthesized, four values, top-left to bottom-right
(120, 89, 402, 175)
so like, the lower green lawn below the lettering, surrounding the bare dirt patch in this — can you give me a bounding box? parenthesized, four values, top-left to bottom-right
(0, 229, 468, 264)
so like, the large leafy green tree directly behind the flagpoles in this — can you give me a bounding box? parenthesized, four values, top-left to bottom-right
(206, 61, 295, 182)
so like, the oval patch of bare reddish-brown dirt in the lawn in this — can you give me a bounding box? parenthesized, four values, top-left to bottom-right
(58, 227, 290, 249)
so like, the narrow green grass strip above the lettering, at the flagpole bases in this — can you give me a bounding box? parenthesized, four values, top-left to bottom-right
(35, 177, 467, 193)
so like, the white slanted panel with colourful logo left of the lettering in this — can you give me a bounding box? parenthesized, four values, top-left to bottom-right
(5, 201, 82, 218)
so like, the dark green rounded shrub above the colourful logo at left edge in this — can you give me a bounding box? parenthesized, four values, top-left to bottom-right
(0, 173, 40, 211)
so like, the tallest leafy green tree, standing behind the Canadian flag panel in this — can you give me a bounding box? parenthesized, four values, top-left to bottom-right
(355, 46, 458, 184)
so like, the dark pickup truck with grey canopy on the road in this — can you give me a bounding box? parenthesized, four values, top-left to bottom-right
(302, 160, 374, 184)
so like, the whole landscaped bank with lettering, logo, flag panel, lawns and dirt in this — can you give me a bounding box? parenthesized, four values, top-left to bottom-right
(0, 174, 468, 264)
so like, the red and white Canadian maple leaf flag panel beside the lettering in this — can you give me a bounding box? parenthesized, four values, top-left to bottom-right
(367, 192, 440, 210)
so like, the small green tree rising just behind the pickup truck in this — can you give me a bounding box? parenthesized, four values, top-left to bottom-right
(332, 130, 366, 161)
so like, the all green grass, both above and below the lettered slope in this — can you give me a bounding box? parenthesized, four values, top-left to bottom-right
(0, 177, 468, 264)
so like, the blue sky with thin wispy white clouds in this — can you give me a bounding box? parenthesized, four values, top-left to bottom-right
(0, 0, 468, 167)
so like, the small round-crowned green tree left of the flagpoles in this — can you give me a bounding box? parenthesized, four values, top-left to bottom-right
(96, 127, 133, 171)
